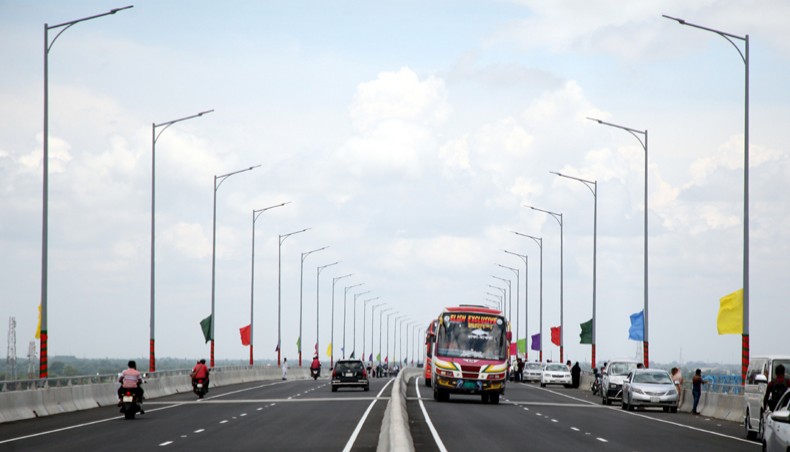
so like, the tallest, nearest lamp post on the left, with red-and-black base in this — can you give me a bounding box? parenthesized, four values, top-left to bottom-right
(38, 5, 133, 378)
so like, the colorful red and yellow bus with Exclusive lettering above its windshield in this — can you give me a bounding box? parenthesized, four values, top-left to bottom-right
(431, 305, 511, 404)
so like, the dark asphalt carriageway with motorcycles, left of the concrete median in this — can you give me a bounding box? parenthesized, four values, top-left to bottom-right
(0, 378, 392, 452)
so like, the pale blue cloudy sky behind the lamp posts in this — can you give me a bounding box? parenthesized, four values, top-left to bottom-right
(0, 0, 790, 364)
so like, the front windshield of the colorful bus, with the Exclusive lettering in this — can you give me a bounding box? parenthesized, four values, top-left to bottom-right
(436, 313, 508, 361)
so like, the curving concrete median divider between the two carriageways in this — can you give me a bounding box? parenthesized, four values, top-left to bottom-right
(376, 367, 422, 452)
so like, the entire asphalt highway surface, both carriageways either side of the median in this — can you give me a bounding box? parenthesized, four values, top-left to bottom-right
(0, 372, 760, 452)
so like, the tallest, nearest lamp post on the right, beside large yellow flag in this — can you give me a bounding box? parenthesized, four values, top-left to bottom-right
(664, 15, 749, 384)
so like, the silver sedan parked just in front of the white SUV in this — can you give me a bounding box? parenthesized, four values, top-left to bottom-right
(623, 369, 678, 413)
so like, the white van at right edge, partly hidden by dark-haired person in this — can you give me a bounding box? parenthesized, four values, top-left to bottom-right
(743, 355, 790, 439)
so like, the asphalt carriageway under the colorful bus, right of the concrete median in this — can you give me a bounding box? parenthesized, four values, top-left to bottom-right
(406, 378, 760, 452)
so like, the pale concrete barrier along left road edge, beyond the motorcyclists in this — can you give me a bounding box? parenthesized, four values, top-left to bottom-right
(0, 366, 309, 423)
